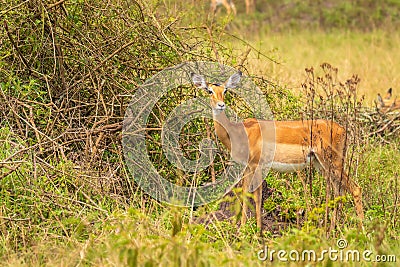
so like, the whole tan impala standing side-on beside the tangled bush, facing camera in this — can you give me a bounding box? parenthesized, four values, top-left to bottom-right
(191, 72, 364, 229)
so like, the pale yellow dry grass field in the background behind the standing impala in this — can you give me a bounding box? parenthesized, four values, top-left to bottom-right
(235, 31, 400, 106)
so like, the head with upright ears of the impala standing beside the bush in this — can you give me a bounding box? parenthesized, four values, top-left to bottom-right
(191, 71, 242, 114)
